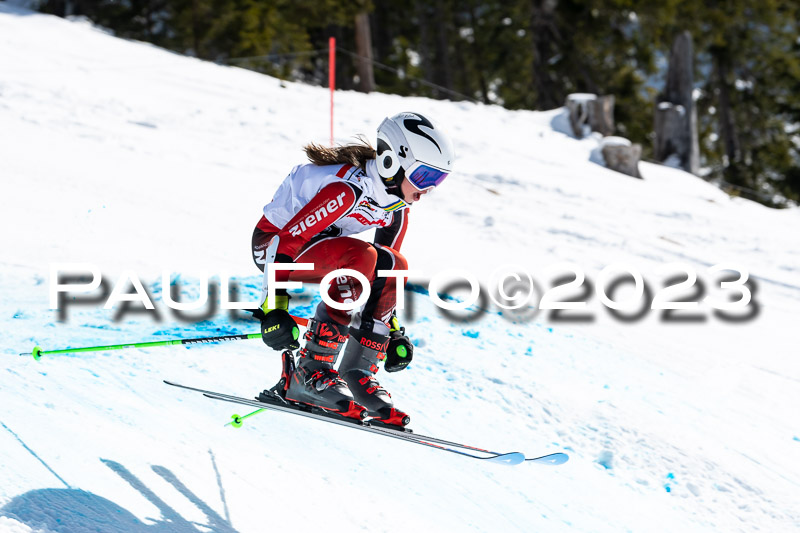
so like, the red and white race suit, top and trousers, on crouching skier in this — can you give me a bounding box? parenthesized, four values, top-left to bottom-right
(252, 160, 408, 330)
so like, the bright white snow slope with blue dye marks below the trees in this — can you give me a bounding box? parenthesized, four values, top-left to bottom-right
(0, 2, 800, 532)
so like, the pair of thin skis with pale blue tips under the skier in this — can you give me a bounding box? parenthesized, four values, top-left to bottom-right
(164, 380, 569, 466)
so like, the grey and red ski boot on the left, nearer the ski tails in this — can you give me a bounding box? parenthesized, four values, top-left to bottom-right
(286, 320, 367, 420)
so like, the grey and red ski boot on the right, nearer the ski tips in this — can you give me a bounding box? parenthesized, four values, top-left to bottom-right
(339, 330, 411, 427)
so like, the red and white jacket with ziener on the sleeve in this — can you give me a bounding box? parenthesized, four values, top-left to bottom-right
(258, 160, 409, 261)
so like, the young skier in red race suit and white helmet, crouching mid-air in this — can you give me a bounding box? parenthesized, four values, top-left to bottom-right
(253, 113, 454, 426)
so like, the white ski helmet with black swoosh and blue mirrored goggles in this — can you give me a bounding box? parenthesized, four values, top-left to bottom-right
(376, 112, 455, 191)
